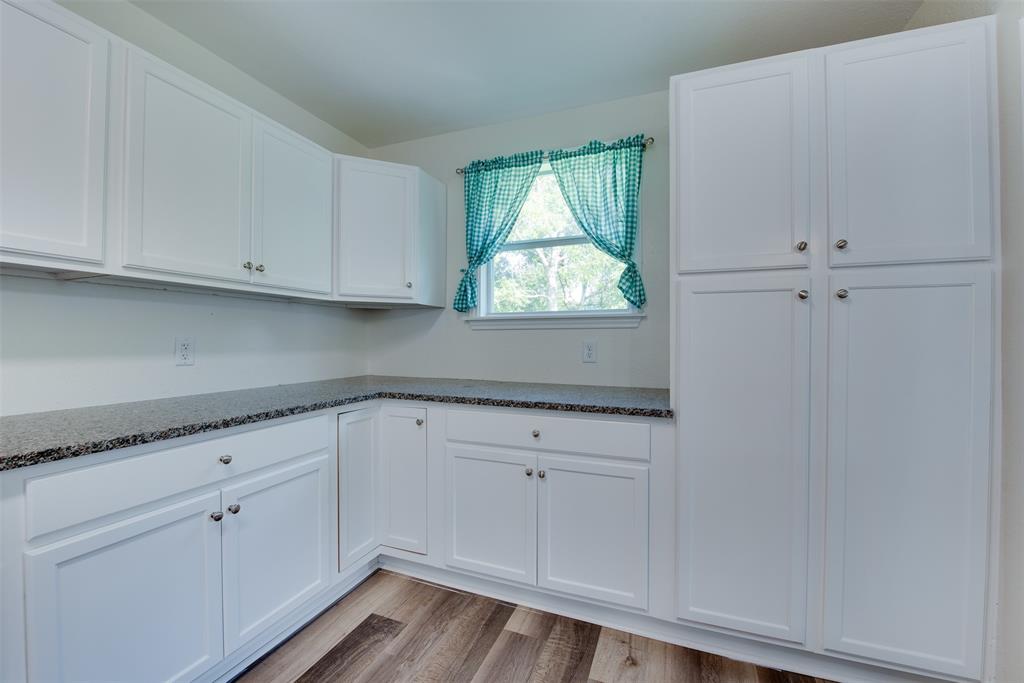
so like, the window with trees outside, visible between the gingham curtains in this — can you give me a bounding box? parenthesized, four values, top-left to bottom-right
(476, 162, 640, 328)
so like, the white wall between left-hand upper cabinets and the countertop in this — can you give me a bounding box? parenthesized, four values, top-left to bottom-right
(0, 275, 366, 415)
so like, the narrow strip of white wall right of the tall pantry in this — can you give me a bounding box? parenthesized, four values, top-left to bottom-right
(906, 0, 1024, 683)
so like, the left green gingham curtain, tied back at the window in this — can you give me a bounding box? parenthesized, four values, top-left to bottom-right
(452, 150, 544, 312)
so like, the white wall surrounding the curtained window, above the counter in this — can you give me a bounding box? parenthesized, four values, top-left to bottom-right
(368, 92, 669, 387)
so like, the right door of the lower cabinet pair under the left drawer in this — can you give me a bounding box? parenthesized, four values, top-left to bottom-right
(223, 454, 330, 653)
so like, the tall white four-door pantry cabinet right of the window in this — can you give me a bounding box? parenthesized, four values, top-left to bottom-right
(671, 17, 999, 679)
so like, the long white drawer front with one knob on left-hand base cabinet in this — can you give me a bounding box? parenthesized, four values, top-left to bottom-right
(26, 416, 330, 541)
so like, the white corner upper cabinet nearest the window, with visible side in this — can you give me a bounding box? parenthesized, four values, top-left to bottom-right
(335, 156, 444, 306)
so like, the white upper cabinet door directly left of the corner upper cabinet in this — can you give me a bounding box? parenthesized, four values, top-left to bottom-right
(252, 118, 332, 294)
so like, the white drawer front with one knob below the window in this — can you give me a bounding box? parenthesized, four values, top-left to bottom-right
(447, 411, 650, 462)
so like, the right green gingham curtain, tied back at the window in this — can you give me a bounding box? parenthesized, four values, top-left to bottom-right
(548, 133, 647, 308)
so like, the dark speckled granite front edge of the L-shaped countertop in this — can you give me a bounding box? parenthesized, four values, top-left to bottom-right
(0, 391, 673, 472)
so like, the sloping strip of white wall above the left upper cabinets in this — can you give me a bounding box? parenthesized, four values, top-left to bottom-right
(57, 0, 367, 156)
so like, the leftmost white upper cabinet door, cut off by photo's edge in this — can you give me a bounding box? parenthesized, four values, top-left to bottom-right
(0, 0, 111, 263)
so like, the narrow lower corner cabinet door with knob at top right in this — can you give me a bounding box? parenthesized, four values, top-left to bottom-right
(381, 407, 427, 553)
